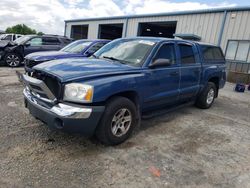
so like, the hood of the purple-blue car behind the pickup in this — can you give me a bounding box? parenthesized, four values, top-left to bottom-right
(25, 51, 83, 61)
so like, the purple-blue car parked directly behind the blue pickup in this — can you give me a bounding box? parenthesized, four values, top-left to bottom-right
(24, 39, 110, 72)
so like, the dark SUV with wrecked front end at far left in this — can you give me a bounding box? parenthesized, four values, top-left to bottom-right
(0, 35, 72, 67)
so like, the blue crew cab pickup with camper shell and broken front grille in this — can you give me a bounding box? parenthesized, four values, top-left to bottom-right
(19, 37, 226, 145)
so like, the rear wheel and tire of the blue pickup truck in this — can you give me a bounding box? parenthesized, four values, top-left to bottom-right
(195, 82, 217, 109)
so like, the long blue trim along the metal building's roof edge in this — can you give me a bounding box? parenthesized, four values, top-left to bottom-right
(65, 6, 250, 23)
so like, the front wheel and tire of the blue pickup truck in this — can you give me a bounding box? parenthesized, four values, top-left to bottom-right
(95, 97, 138, 145)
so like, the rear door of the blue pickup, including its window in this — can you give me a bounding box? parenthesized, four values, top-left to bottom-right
(177, 42, 201, 100)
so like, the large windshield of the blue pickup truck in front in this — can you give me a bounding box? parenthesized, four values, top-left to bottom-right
(94, 39, 155, 66)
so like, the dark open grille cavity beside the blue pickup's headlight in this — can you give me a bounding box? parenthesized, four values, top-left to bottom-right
(32, 71, 61, 99)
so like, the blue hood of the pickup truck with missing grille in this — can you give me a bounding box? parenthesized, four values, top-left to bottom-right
(34, 58, 140, 82)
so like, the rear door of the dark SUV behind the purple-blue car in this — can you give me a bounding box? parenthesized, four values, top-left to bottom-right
(42, 37, 61, 51)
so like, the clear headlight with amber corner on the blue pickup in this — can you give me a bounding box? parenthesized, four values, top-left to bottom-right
(63, 83, 94, 103)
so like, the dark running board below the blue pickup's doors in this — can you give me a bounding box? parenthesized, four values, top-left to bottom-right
(142, 101, 194, 119)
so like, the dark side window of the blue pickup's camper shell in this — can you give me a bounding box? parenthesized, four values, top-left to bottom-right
(202, 46, 224, 61)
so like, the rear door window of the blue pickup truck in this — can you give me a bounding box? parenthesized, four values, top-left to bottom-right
(178, 44, 195, 64)
